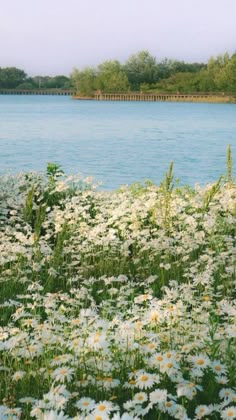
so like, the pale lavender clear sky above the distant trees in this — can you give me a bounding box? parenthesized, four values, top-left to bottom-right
(0, 0, 236, 76)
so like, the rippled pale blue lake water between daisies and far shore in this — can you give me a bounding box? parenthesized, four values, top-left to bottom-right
(0, 95, 236, 189)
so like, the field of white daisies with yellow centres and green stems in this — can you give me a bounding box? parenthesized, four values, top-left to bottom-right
(0, 168, 236, 420)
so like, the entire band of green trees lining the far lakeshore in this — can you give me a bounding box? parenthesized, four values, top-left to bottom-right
(0, 50, 236, 96)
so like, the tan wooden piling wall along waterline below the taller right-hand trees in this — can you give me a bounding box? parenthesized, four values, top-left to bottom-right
(92, 92, 236, 103)
